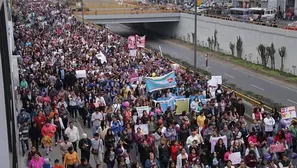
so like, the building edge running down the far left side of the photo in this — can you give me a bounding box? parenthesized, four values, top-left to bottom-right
(0, 0, 22, 168)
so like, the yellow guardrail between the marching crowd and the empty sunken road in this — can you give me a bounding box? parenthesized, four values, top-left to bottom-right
(75, 16, 297, 122)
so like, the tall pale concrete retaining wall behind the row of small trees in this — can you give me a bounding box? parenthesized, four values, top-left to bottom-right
(145, 14, 297, 73)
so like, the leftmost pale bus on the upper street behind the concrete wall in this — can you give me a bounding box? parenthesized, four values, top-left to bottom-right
(230, 8, 253, 22)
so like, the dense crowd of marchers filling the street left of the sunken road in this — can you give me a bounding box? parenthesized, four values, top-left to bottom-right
(13, 0, 297, 168)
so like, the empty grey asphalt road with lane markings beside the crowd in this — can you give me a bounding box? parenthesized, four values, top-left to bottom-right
(106, 24, 297, 106)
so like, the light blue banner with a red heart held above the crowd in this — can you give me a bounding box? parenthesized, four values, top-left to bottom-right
(145, 72, 176, 92)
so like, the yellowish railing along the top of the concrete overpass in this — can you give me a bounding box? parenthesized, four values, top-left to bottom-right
(74, 10, 176, 15)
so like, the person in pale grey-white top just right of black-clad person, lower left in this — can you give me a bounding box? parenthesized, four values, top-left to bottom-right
(91, 133, 104, 165)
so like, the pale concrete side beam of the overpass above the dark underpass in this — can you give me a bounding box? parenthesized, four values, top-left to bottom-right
(84, 13, 180, 24)
